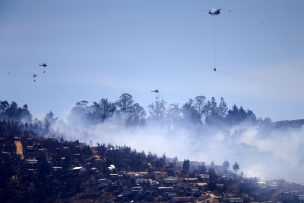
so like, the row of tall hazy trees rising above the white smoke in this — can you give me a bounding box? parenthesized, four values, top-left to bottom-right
(70, 93, 258, 126)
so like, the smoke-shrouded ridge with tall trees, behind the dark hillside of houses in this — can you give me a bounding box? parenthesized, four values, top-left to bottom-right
(1, 93, 304, 184)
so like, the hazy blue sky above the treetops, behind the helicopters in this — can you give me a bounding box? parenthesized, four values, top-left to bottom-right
(0, 0, 304, 120)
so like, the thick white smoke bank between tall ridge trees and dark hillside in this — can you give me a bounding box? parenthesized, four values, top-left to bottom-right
(53, 112, 304, 184)
